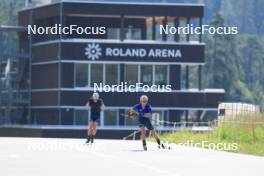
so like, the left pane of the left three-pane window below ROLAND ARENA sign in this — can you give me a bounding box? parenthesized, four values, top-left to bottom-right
(75, 64, 88, 87)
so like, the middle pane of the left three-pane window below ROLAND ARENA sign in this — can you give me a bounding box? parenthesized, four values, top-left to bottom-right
(91, 64, 103, 87)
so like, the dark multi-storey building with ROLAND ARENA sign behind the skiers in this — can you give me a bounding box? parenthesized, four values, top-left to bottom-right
(19, 1, 224, 129)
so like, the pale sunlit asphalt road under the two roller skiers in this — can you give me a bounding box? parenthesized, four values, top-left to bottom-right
(0, 138, 264, 176)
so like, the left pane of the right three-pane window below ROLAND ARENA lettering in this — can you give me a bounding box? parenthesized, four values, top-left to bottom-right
(125, 65, 138, 85)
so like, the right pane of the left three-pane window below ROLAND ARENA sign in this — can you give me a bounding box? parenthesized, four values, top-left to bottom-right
(105, 64, 118, 85)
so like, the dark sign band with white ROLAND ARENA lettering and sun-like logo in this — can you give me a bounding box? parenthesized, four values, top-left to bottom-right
(62, 42, 204, 63)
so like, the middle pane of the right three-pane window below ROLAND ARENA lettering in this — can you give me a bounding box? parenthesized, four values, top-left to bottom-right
(140, 65, 153, 85)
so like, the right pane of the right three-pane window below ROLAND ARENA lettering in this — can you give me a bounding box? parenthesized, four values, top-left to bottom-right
(155, 65, 168, 85)
